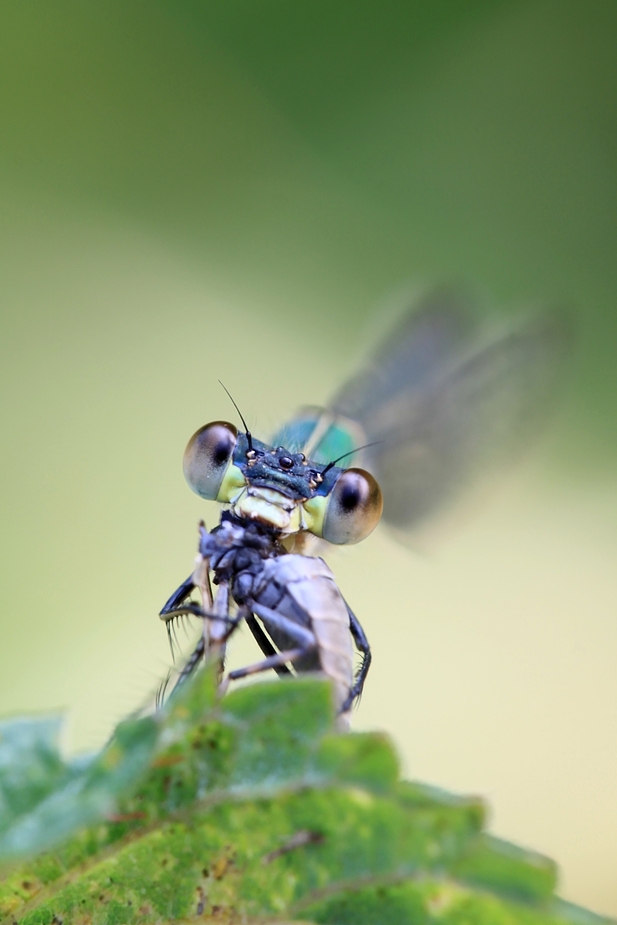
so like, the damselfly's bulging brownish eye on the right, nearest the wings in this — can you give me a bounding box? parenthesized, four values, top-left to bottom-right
(322, 469, 383, 545)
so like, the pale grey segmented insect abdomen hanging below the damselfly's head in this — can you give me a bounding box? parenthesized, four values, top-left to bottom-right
(255, 554, 353, 710)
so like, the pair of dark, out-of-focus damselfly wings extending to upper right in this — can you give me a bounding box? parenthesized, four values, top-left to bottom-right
(329, 291, 571, 533)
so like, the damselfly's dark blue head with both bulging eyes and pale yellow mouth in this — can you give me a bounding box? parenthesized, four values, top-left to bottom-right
(184, 421, 382, 545)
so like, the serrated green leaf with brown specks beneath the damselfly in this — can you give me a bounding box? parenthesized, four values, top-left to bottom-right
(0, 670, 604, 925)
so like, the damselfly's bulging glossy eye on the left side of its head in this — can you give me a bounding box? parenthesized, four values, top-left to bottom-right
(182, 421, 238, 501)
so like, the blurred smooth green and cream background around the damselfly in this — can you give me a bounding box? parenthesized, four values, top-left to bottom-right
(0, 0, 617, 914)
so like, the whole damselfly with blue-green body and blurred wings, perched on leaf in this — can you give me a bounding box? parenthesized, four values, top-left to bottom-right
(160, 291, 568, 717)
